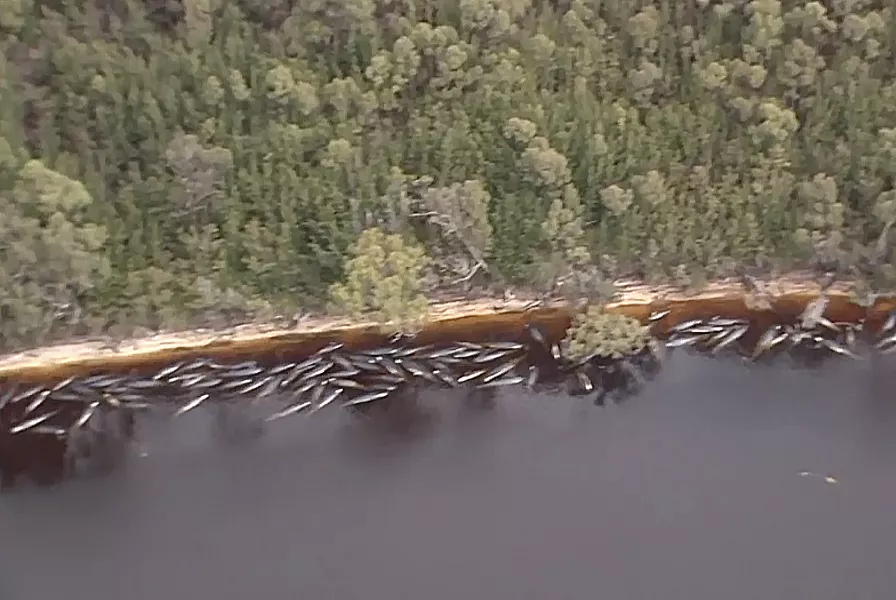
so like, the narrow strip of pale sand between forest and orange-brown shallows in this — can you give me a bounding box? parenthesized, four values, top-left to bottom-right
(0, 275, 872, 377)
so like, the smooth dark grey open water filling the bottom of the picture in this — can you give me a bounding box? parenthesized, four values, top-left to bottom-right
(0, 354, 896, 600)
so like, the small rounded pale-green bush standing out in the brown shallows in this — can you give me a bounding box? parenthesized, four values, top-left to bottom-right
(564, 304, 650, 360)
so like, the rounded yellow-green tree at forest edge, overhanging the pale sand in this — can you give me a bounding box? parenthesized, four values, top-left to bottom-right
(330, 228, 428, 331)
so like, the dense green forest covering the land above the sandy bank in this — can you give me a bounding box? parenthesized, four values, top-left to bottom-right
(0, 0, 896, 348)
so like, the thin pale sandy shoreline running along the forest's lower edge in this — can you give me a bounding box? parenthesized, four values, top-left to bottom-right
(0, 273, 884, 377)
